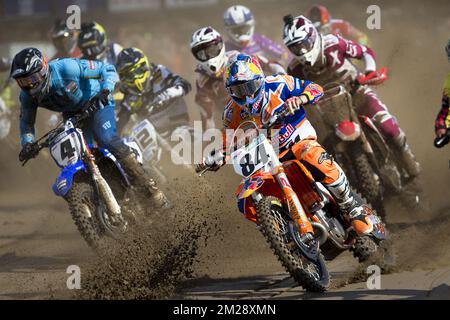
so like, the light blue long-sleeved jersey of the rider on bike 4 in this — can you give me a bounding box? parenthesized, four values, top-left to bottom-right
(20, 58, 119, 145)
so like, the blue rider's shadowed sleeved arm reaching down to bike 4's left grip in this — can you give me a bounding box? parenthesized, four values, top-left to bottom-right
(19, 91, 37, 145)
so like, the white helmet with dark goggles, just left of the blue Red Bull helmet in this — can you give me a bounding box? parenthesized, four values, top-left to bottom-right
(190, 27, 227, 76)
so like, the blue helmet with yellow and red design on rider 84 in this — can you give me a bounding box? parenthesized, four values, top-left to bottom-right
(225, 53, 265, 113)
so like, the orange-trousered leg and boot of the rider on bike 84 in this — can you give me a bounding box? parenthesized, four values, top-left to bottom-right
(291, 138, 373, 235)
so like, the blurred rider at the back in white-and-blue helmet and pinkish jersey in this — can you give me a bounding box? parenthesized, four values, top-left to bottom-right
(223, 5, 292, 74)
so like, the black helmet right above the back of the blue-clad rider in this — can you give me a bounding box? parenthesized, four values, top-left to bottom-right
(78, 21, 107, 60)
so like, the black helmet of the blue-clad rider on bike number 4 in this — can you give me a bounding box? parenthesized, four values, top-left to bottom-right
(10, 48, 50, 96)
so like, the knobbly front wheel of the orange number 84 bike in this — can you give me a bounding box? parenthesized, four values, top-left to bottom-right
(257, 196, 330, 292)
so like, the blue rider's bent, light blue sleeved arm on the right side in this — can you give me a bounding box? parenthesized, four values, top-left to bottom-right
(75, 60, 119, 92)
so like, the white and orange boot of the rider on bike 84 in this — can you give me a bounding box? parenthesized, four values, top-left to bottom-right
(325, 164, 373, 236)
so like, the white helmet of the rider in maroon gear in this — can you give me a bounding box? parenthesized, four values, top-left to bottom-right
(283, 15, 322, 66)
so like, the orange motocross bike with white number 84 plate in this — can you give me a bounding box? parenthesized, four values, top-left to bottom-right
(197, 111, 387, 292)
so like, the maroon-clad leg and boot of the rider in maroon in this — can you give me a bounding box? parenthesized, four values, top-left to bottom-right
(355, 89, 420, 178)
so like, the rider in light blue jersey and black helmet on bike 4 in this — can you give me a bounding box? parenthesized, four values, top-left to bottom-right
(11, 48, 169, 209)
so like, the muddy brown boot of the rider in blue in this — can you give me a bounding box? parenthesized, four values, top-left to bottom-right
(120, 153, 172, 210)
